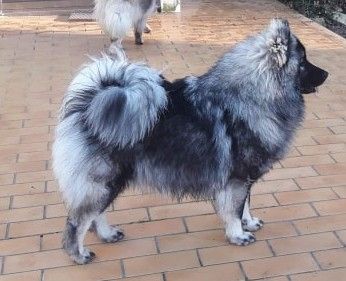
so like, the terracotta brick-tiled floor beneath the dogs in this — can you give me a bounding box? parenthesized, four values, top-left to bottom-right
(0, 0, 346, 281)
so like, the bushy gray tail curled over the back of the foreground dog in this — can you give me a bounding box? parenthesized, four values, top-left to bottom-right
(62, 53, 167, 148)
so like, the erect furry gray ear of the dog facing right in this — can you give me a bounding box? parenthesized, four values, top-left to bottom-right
(265, 19, 290, 68)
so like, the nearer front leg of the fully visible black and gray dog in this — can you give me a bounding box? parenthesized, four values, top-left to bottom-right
(215, 179, 255, 246)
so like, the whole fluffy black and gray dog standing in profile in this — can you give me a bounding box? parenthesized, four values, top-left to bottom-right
(53, 20, 327, 263)
